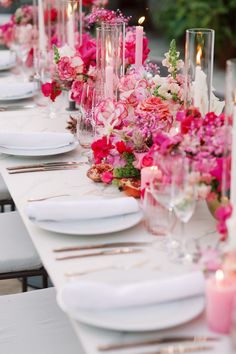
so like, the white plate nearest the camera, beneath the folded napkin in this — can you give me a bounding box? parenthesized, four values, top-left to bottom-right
(57, 296, 205, 332)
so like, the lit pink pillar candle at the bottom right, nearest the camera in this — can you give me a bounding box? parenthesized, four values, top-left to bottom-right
(206, 270, 236, 334)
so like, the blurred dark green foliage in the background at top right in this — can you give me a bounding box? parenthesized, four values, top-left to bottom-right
(155, 0, 236, 63)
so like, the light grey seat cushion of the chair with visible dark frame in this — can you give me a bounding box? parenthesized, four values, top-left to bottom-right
(0, 212, 42, 273)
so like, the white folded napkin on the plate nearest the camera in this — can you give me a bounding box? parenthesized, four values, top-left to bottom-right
(58, 271, 205, 311)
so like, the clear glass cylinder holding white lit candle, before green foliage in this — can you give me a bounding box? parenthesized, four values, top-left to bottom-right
(185, 28, 215, 115)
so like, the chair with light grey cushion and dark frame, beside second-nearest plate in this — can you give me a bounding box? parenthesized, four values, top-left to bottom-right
(0, 211, 48, 292)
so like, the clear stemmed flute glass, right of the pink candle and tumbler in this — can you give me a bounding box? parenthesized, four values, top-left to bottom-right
(172, 157, 196, 263)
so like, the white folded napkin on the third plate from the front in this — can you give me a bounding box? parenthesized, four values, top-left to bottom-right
(0, 132, 74, 150)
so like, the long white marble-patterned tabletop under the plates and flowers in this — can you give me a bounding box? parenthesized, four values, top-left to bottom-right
(0, 81, 234, 354)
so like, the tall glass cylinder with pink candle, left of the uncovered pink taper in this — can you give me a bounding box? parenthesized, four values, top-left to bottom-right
(97, 22, 125, 99)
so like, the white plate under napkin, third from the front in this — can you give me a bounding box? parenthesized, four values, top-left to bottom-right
(0, 142, 78, 156)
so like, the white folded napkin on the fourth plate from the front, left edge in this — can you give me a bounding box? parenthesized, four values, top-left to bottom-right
(0, 82, 36, 100)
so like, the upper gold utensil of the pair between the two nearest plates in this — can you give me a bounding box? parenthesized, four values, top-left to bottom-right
(53, 242, 151, 253)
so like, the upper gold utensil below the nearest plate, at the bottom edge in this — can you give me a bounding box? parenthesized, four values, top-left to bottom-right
(97, 336, 219, 352)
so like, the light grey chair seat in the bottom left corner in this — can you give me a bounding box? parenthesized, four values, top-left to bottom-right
(0, 288, 84, 354)
